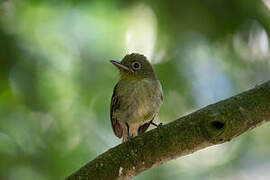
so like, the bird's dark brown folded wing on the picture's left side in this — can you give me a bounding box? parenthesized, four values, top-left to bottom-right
(110, 84, 123, 138)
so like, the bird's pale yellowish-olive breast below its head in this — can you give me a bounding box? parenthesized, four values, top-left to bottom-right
(116, 80, 162, 123)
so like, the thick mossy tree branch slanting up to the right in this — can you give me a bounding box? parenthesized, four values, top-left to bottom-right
(67, 81, 270, 180)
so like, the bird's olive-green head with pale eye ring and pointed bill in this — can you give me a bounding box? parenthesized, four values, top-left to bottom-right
(111, 53, 156, 80)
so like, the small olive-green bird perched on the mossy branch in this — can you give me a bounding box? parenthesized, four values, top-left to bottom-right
(110, 53, 162, 142)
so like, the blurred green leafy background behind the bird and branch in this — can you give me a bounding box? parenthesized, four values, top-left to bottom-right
(0, 0, 270, 180)
